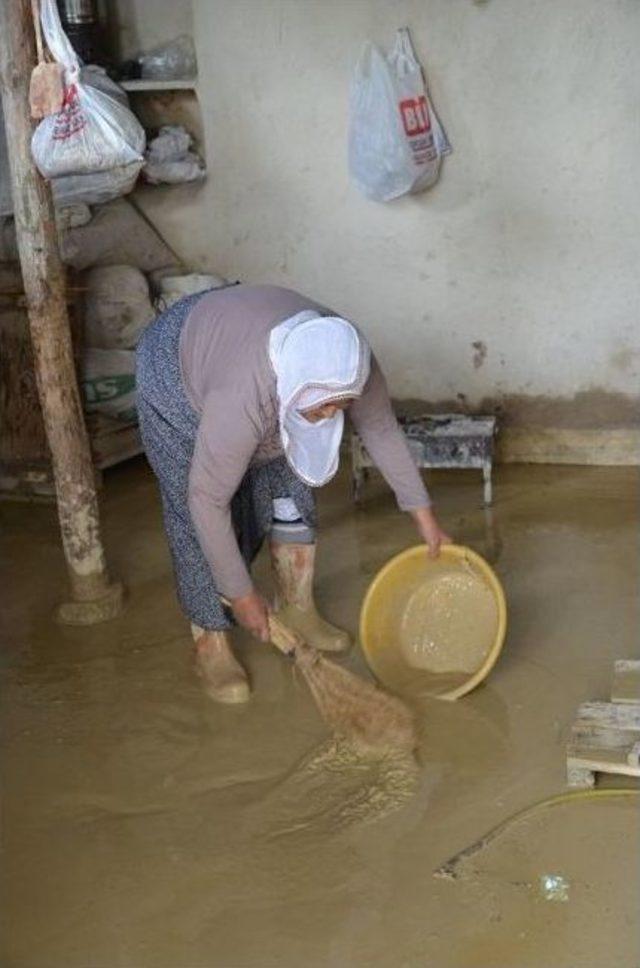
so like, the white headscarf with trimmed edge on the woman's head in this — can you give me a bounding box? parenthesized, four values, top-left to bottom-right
(269, 310, 371, 487)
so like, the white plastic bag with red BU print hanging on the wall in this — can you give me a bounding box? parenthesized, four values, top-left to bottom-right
(349, 28, 451, 202)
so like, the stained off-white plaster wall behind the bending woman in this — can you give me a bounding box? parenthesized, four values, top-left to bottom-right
(116, 0, 640, 459)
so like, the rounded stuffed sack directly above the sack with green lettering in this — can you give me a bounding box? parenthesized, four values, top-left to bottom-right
(82, 266, 155, 350)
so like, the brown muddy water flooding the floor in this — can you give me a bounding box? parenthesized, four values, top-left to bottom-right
(0, 461, 640, 968)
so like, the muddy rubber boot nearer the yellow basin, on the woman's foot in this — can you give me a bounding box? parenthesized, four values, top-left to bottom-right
(270, 541, 351, 652)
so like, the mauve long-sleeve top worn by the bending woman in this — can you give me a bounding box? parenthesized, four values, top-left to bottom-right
(180, 285, 429, 598)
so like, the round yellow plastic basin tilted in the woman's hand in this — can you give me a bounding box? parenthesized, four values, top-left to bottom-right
(360, 545, 507, 699)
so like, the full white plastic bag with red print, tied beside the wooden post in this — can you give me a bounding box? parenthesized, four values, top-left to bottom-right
(31, 0, 145, 178)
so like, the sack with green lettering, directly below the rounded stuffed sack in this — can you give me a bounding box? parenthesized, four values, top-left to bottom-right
(81, 347, 137, 423)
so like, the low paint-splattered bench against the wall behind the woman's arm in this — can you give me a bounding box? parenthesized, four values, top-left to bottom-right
(351, 413, 496, 505)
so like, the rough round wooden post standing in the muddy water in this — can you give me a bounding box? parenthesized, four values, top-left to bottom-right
(0, 0, 122, 625)
